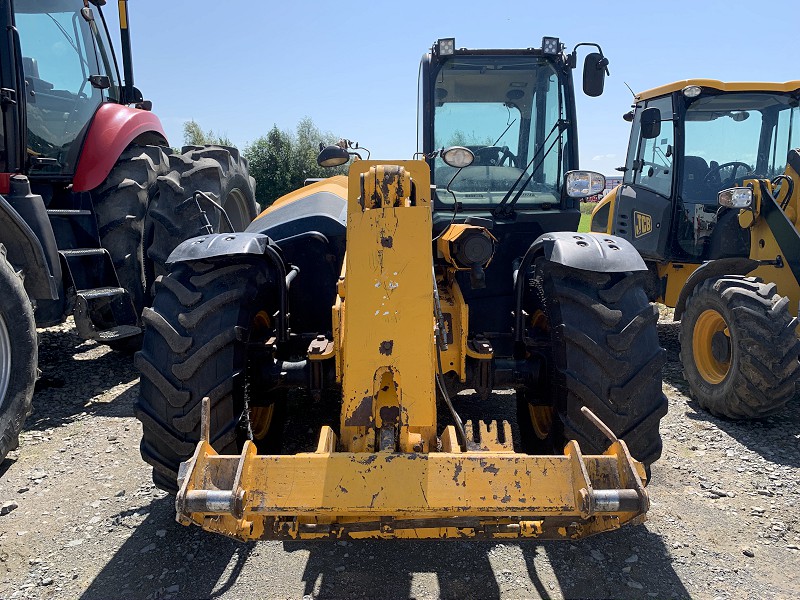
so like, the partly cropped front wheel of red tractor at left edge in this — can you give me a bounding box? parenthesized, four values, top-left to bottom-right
(0, 244, 38, 462)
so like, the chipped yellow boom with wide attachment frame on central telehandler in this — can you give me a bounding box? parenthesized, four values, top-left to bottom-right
(176, 161, 649, 540)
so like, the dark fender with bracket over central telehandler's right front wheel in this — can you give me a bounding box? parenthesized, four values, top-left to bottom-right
(514, 231, 647, 342)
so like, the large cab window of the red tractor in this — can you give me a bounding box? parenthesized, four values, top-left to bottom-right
(14, 0, 118, 173)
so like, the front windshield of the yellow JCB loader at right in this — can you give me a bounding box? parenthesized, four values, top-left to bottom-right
(681, 93, 800, 206)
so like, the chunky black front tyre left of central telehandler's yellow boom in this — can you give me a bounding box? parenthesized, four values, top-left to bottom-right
(136, 257, 284, 493)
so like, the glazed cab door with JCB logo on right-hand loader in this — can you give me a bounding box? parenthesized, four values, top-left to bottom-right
(612, 96, 675, 260)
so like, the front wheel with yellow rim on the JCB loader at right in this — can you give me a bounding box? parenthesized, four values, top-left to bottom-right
(680, 275, 800, 419)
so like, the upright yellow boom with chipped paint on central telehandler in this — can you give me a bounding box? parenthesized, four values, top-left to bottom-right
(335, 161, 436, 452)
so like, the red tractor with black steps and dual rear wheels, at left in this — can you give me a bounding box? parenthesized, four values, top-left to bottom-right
(0, 0, 256, 460)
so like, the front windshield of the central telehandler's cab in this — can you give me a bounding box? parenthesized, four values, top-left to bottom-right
(433, 56, 568, 206)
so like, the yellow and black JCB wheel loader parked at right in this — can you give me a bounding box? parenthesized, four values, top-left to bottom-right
(591, 80, 800, 419)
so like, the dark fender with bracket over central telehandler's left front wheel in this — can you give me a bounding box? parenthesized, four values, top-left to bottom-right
(167, 231, 292, 342)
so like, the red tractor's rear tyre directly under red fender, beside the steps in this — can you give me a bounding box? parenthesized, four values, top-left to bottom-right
(91, 144, 167, 352)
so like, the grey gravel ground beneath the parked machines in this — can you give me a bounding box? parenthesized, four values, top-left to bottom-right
(0, 315, 800, 599)
